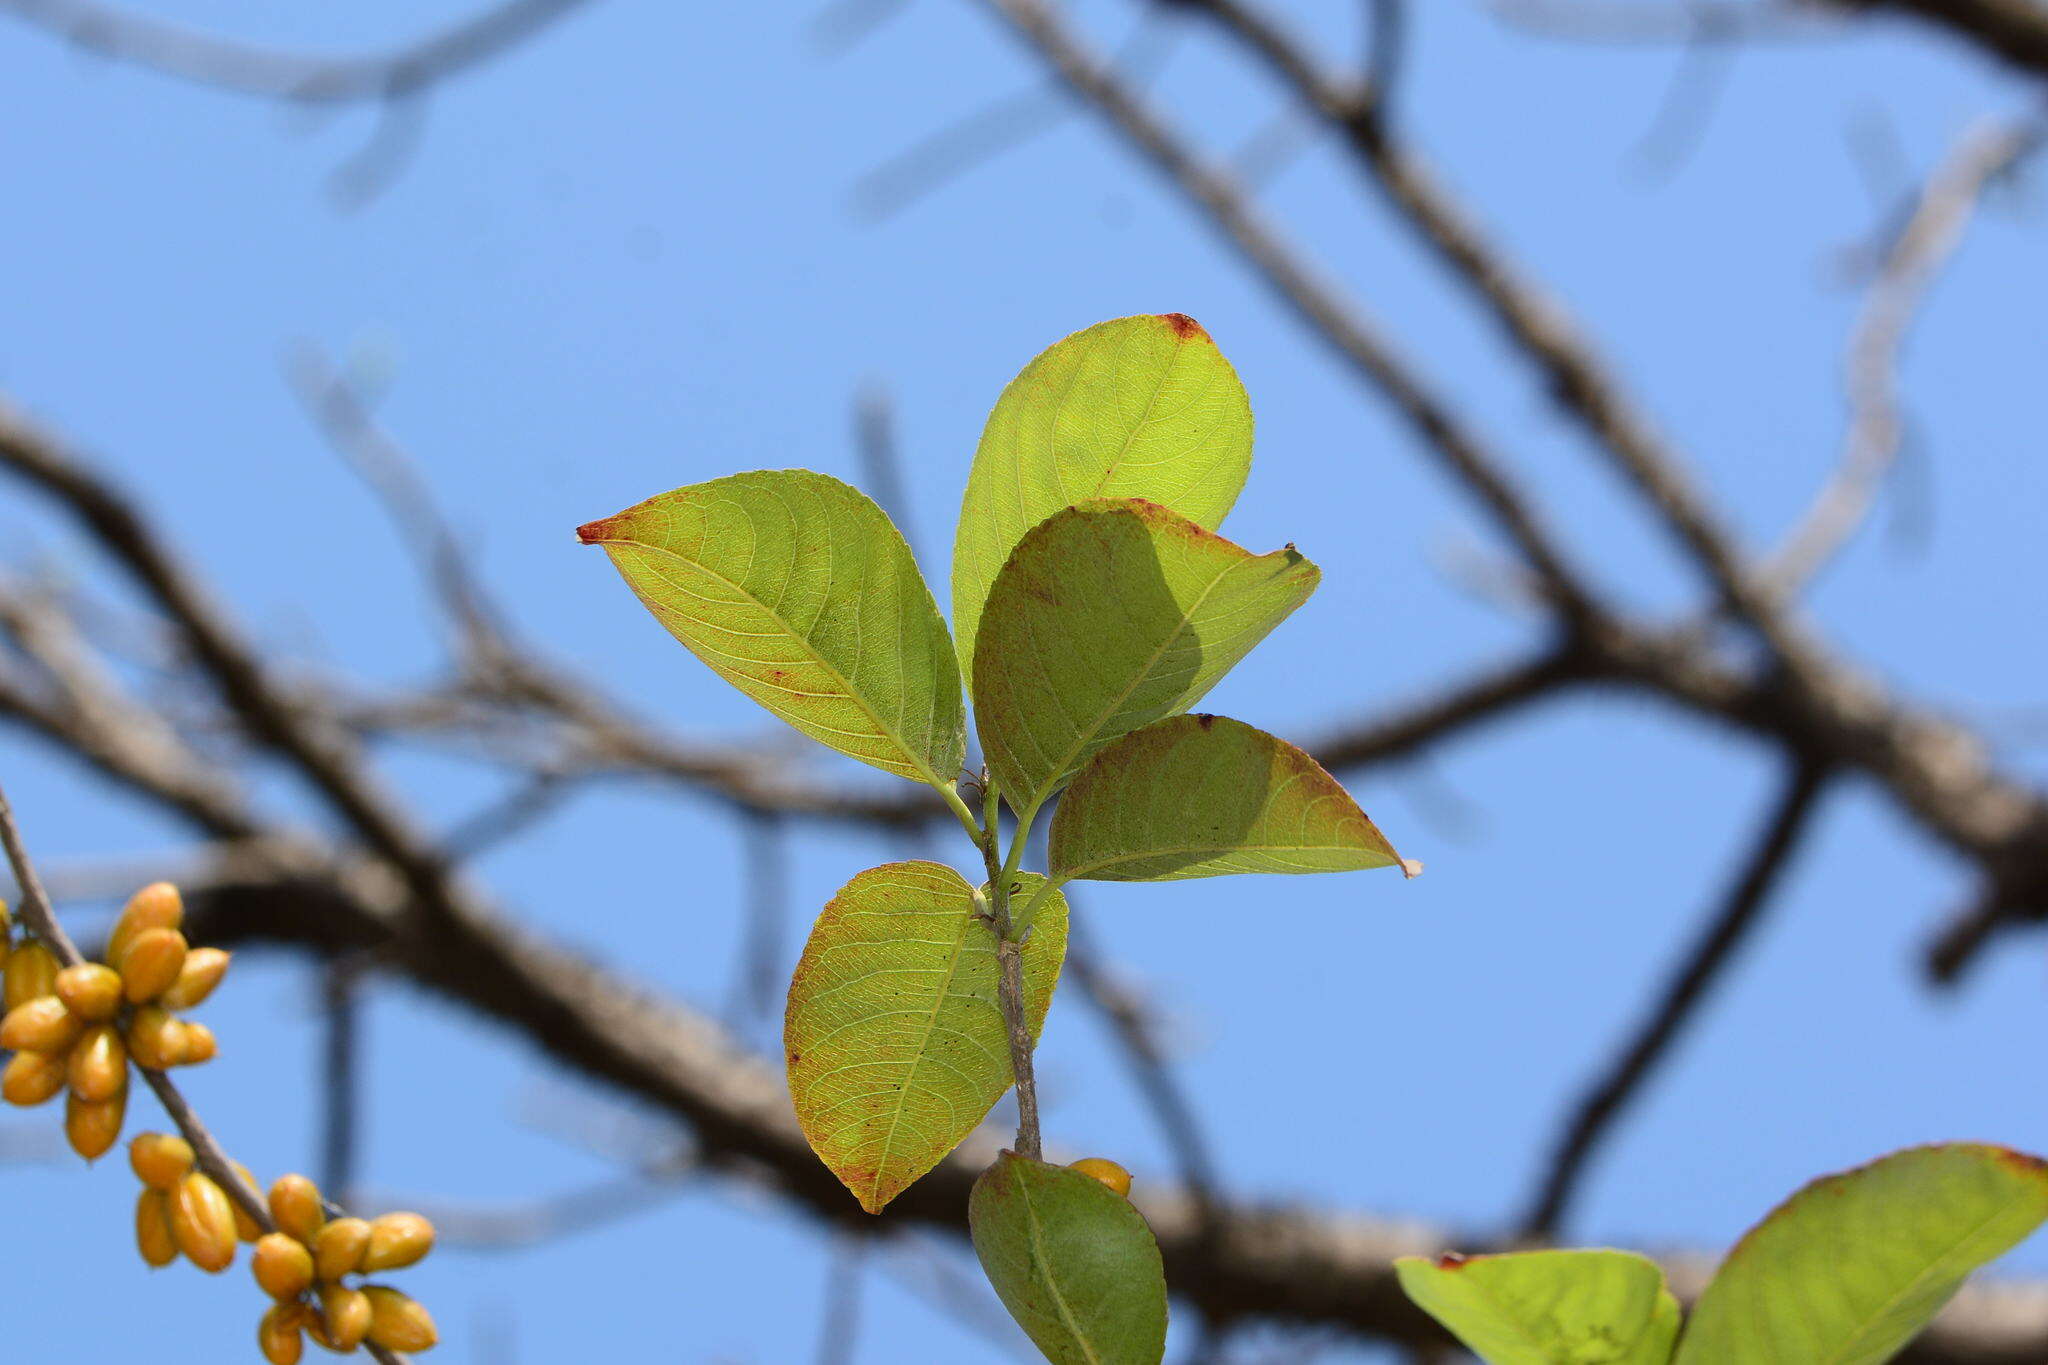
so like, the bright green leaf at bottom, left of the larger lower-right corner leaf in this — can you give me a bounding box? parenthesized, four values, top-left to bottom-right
(1395, 1250, 1679, 1365)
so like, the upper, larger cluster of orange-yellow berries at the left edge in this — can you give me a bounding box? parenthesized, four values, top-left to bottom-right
(0, 882, 227, 1160)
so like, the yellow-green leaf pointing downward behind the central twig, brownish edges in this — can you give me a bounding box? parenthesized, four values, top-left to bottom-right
(782, 862, 1067, 1214)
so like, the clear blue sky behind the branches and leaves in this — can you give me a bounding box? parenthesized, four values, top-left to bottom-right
(0, 0, 2048, 1365)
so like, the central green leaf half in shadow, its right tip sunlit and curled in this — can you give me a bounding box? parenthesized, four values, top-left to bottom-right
(973, 499, 1321, 812)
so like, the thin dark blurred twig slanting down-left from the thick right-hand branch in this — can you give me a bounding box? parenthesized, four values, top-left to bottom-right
(1520, 761, 1829, 1242)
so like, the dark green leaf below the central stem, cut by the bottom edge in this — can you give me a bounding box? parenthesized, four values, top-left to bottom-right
(967, 1152, 1165, 1365)
